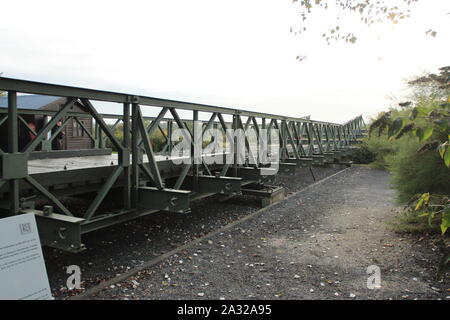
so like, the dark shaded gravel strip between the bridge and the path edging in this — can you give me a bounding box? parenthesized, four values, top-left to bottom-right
(44, 167, 342, 299)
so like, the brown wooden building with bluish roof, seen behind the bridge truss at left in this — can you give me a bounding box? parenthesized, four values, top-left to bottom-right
(0, 95, 94, 151)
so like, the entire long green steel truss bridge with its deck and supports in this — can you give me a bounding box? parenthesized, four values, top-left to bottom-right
(0, 77, 365, 252)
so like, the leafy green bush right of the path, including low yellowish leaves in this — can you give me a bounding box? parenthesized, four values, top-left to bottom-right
(369, 67, 450, 234)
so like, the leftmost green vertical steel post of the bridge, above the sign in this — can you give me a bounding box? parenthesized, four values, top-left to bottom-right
(8, 91, 20, 215)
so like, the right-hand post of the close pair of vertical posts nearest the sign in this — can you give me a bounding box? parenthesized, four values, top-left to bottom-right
(131, 103, 139, 208)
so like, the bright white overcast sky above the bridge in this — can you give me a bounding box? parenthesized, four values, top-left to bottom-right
(0, 0, 450, 122)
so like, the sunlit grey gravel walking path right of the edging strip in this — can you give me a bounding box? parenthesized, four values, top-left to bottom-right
(91, 167, 450, 299)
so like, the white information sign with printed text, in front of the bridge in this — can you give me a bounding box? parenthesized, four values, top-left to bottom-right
(0, 213, 53, 300)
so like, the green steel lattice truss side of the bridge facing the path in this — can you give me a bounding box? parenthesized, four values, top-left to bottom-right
(0, 78, 364, 250)
